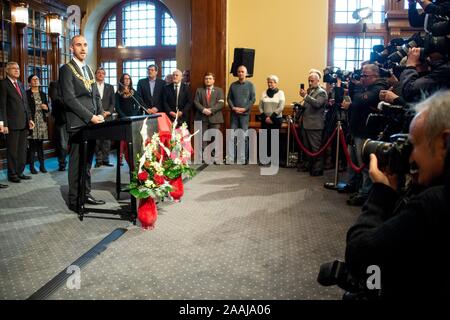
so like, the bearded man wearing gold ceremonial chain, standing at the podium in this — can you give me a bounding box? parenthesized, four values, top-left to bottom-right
(59, 35, 105, 212)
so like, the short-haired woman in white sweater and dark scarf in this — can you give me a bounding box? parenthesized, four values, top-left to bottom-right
(259, 75, 286, 160)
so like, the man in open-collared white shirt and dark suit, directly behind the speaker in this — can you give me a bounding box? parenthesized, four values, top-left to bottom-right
(95, 67, 115, 168)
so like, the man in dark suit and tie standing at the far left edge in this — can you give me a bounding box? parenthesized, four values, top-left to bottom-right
(0, 62, 34, 183)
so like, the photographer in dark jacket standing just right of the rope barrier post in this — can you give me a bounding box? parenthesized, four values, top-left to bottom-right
(342, 64, 389, 206)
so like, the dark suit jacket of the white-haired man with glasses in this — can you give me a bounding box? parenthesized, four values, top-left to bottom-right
(163, 83, 192, 123)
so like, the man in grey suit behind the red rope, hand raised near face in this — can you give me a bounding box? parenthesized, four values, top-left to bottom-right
(300, 72, 328, 176)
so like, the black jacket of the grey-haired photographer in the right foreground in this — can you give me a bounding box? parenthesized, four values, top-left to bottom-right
(345, 183, 450, 299)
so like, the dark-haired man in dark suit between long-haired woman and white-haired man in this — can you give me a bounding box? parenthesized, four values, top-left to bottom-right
(136, 64, 166, 114)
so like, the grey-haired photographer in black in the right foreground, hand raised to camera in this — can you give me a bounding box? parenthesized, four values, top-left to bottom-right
(345, 91, 450, 299)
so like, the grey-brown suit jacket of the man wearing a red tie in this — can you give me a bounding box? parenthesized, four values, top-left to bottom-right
(194, 87, 225, 123)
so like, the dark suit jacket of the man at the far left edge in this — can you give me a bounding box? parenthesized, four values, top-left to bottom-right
(0, 78, 31, 130)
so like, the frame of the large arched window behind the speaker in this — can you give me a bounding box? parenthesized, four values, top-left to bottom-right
(97, 0, 177, 79)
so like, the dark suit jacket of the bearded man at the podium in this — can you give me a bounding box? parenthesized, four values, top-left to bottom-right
(59, 60, 103, 132)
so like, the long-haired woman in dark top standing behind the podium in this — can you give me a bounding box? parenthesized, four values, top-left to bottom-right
(116, 73, 142, 165)
